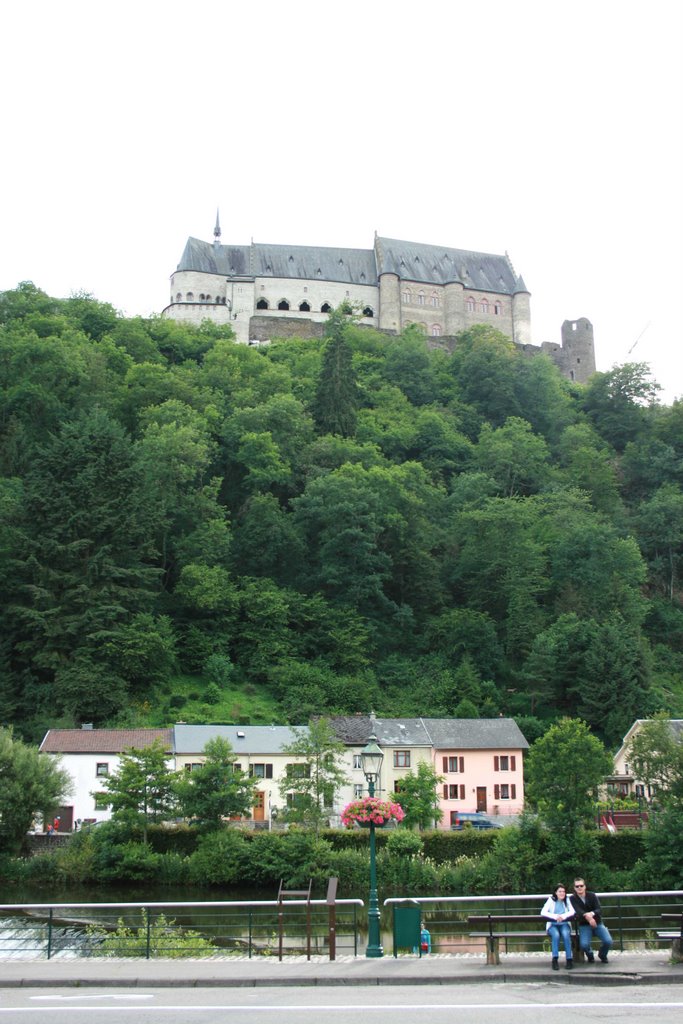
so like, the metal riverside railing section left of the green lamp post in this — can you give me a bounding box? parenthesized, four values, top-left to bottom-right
(0, 899, 364, 959)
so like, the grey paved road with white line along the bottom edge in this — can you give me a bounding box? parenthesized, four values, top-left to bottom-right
(0, 981, 683, 1024)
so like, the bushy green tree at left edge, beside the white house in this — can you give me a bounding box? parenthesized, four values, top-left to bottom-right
(0, 727, 72, 854)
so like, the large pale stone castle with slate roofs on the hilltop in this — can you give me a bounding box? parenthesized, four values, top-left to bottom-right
(162, 217, 595, 382)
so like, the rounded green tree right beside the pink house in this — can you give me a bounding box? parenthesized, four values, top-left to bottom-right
(524, 718, 612, 851)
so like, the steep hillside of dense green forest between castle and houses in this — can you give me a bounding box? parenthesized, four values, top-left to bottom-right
(0, 284, 683, 745)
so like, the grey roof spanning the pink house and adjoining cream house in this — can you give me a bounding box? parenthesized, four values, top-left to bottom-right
(330, 715, 528, 751)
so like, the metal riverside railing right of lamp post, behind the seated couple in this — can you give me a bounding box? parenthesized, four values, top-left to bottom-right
(384, 889, 683, 953)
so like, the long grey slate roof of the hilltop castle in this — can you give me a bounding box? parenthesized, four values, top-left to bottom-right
(177, 237, 526, 295)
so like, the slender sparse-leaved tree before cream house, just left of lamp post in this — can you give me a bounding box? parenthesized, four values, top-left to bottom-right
(280, 718, 348, 831)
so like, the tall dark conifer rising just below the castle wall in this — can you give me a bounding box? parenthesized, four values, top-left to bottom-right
(312, 306, 358, 437)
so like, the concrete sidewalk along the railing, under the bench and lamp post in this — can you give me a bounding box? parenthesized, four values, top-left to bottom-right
(0, 950, 683, 989)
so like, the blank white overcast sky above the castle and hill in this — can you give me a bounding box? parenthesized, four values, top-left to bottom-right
(0, 0, 683, 401)
